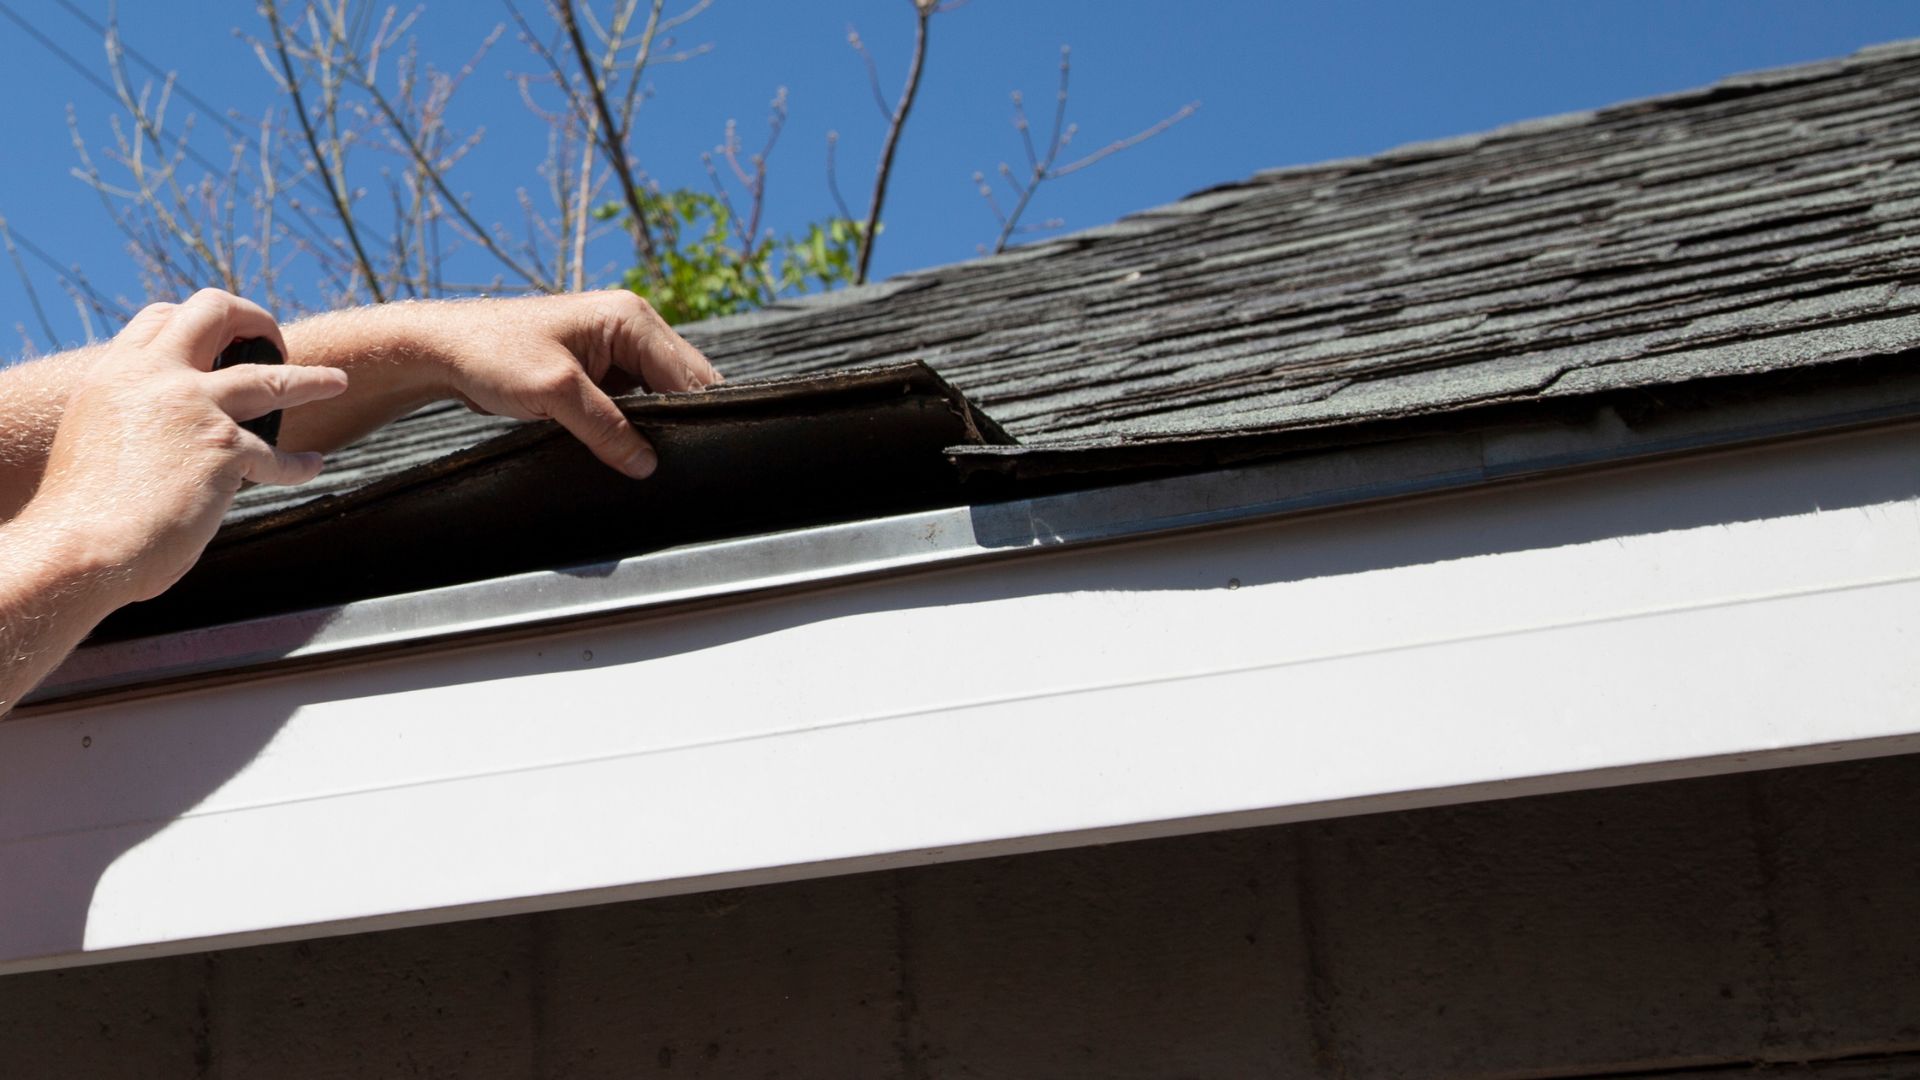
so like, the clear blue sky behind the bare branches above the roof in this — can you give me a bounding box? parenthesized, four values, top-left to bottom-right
(0, 0, 1920, 356)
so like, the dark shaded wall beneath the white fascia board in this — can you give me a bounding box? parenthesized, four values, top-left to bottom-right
(0, 757, 1920, 1080)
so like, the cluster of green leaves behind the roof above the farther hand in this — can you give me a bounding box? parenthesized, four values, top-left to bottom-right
(593, 188, 862, 323)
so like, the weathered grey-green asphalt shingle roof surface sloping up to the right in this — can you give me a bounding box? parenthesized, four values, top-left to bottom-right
(234, 42, 1920, 519)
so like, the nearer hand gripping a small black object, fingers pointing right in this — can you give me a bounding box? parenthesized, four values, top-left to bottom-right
(23, 288, 348, 603)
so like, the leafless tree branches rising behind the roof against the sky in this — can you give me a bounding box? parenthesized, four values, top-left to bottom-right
(33, 0, 1136, 327)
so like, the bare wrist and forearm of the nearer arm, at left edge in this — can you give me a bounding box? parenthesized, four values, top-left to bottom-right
(0, 505, 127, 717)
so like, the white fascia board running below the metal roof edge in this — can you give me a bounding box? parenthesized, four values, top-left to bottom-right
(0, 427, 1920, 970)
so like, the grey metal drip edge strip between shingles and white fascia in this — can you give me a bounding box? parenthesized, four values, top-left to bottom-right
(33, 361, 1920, 715)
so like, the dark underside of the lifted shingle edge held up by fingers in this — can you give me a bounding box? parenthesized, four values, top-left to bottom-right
(100, 363, 1006, 638)
